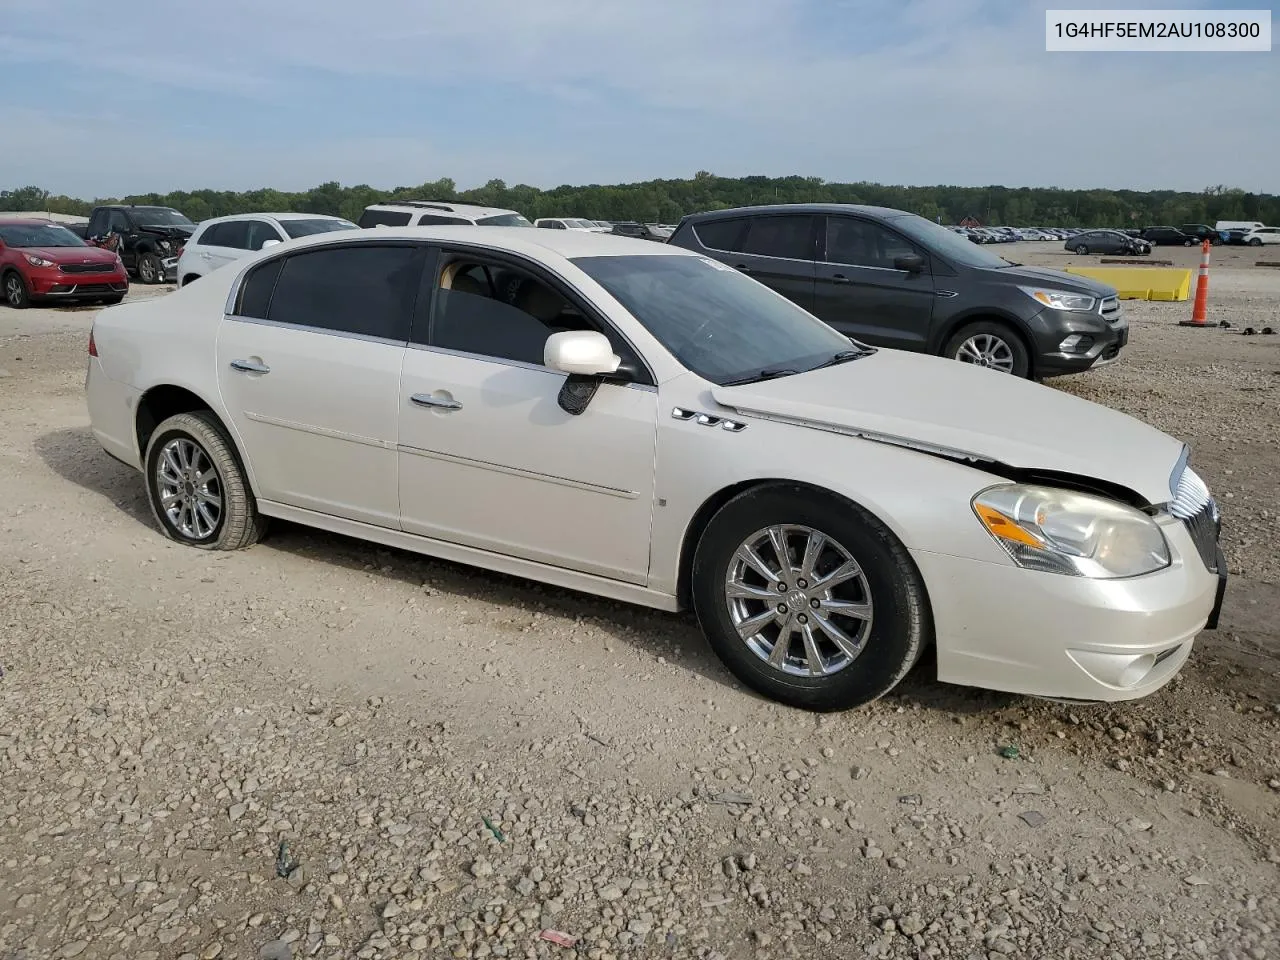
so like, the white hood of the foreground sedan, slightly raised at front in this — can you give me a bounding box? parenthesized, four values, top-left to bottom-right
(712, 349, 1184, 503)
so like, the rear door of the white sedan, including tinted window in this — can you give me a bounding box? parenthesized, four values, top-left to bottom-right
(218, 241, 426, 527)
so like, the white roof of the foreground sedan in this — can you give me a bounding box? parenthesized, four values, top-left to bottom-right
(240, 224, 700, 259)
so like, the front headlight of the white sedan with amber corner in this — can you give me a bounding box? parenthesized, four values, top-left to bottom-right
(973, 484, 1170, 580)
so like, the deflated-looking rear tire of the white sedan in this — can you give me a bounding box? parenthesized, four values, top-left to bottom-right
(143, 410, 266, 550)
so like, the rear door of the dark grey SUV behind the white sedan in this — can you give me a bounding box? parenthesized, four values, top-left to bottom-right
(695, 214, 822, 311)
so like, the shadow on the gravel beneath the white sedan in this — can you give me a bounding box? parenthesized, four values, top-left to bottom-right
(35, 428, 1024, 714)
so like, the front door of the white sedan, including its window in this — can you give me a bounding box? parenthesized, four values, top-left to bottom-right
(398, 252, 658, 584)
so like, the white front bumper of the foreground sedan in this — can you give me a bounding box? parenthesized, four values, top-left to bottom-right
(913, 518, 1226, 701)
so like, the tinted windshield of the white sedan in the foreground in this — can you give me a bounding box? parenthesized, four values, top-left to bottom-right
(573, 255, 854, 384)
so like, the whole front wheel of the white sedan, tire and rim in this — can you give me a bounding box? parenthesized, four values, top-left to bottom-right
(692, 484, 932, 712)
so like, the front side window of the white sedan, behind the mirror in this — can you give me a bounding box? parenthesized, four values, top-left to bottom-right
(430, 256, 641, 370)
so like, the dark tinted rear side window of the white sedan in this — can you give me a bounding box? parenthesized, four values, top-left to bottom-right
(249, 243, 425, 342)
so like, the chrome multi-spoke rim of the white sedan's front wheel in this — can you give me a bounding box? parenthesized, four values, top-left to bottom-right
(724, 525, 872, 677)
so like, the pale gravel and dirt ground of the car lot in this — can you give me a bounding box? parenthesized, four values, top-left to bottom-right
(0, 243, 1280, 960)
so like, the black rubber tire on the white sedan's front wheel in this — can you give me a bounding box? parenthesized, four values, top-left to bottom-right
(692, 484, 933, 712)
